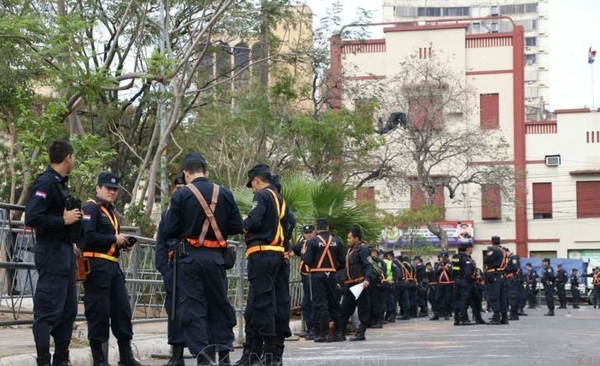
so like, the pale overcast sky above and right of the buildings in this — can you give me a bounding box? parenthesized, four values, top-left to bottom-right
(306, 0, 600, 110)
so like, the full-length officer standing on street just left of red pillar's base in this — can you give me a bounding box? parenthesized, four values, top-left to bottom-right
(483, 236, 508, 325)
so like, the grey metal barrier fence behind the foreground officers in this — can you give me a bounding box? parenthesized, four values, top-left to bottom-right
(0, 203, 302, 339)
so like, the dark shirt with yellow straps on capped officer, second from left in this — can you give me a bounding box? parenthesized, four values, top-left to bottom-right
(79, 196, 120, 257)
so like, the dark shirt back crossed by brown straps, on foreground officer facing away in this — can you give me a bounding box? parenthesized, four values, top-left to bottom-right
(165, 177, 242, 240)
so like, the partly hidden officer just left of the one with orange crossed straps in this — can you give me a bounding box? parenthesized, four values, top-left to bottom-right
(292, 225, 317, 341)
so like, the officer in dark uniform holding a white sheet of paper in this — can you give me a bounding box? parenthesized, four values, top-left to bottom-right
(336, 227, 375, 341)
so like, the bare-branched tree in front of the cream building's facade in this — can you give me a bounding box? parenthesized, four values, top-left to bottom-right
(379, 54, 514, 248)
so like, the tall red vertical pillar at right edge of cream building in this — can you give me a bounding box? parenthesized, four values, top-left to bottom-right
(512, 26, 529, 257)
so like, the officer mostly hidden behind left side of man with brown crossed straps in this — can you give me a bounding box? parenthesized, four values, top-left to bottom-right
(154, 174, 185, 366)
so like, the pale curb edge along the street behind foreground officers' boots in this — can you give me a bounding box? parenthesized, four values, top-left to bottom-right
(0, 320, 302, 366)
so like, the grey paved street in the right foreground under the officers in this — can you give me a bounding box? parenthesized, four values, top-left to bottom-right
(145, 306, 600, 366)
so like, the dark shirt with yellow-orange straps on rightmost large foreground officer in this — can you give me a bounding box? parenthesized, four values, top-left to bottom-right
(244, 186, 291, 247)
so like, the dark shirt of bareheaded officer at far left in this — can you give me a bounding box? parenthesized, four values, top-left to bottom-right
(25, 166, 69, 239)
